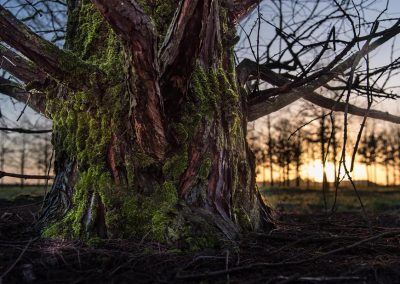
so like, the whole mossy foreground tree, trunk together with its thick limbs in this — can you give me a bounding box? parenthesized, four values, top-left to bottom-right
(0, 3, 400, 242)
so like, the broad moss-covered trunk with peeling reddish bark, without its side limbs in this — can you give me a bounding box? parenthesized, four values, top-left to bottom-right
(40, 0, 272, 248)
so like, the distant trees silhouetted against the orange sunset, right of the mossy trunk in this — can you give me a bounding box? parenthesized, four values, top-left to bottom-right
(248, 110, 400, 190)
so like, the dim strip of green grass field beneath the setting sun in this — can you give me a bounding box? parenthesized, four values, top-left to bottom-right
(261, 188, 400, 213)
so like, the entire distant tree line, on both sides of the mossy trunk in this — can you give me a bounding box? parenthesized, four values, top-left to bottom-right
(0, 106, 400, 189)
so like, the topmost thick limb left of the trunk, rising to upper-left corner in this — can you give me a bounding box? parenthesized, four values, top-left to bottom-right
(0, 5, 103, 89)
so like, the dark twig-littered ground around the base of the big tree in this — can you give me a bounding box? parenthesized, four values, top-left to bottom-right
(0, 188, 400, 283)
